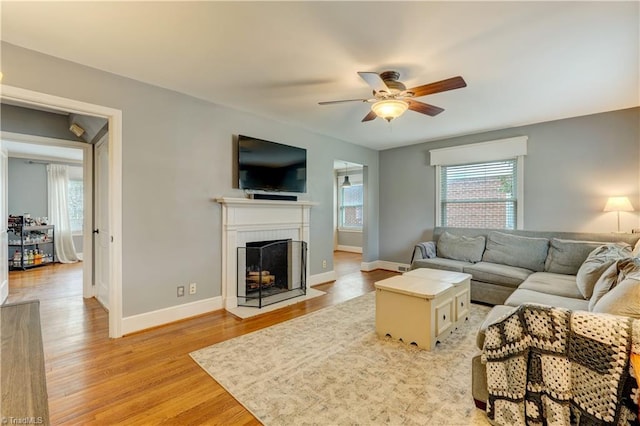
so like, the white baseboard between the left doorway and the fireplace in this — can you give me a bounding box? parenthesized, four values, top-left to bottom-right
(122, 296, 223, 335)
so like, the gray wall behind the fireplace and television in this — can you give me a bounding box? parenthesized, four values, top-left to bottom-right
(2, 43, 378, 316)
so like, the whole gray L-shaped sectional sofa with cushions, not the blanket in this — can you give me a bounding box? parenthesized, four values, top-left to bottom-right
(411, 228, 640, 408)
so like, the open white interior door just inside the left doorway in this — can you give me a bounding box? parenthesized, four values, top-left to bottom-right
(94, 136, 111, 309)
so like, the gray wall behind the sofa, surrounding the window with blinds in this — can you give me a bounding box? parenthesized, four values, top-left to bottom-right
(380, 108, 640, 262)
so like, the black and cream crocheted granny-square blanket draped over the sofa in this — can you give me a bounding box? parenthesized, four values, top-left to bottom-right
(482, 305, 640, 425)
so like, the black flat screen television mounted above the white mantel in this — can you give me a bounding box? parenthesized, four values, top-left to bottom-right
(238, 135, 307, 192)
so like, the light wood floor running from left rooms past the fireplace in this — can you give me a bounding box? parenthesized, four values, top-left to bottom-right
(9, 252, 395, 425)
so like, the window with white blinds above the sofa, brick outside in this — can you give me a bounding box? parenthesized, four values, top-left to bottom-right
(440, 159, 518, 229)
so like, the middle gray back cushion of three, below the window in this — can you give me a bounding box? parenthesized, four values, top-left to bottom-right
(482, 231, 549, 271)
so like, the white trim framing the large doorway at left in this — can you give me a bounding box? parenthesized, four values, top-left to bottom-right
(0, 85, 122, 338)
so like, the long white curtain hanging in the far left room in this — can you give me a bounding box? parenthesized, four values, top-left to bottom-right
(47, 164, 79, 263)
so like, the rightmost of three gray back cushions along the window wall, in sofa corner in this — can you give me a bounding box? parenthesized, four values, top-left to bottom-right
(544, 238, 603, 275)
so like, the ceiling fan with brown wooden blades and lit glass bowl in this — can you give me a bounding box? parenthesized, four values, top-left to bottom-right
(318, 71, 467, 122)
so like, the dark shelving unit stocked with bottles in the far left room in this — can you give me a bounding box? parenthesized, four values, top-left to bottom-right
(8, 216, 55, 270)
